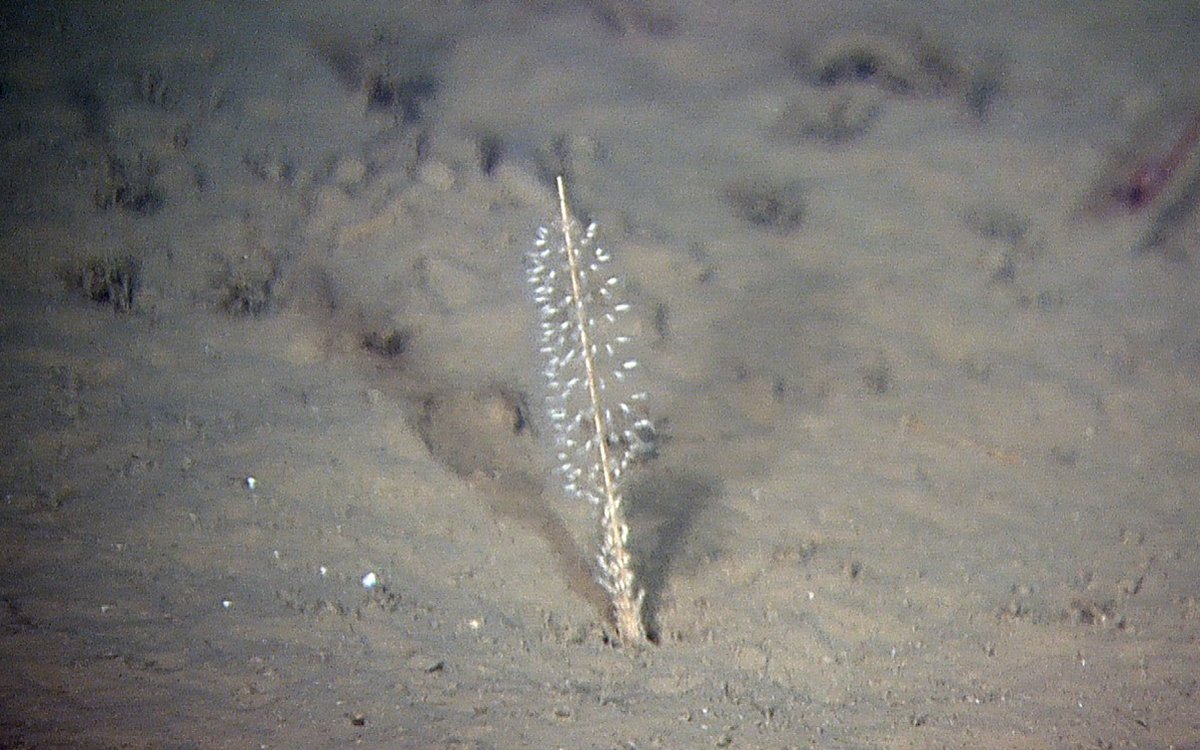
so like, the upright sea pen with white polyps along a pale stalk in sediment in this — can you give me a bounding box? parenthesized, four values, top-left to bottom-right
(526, 176, 653, 644)
